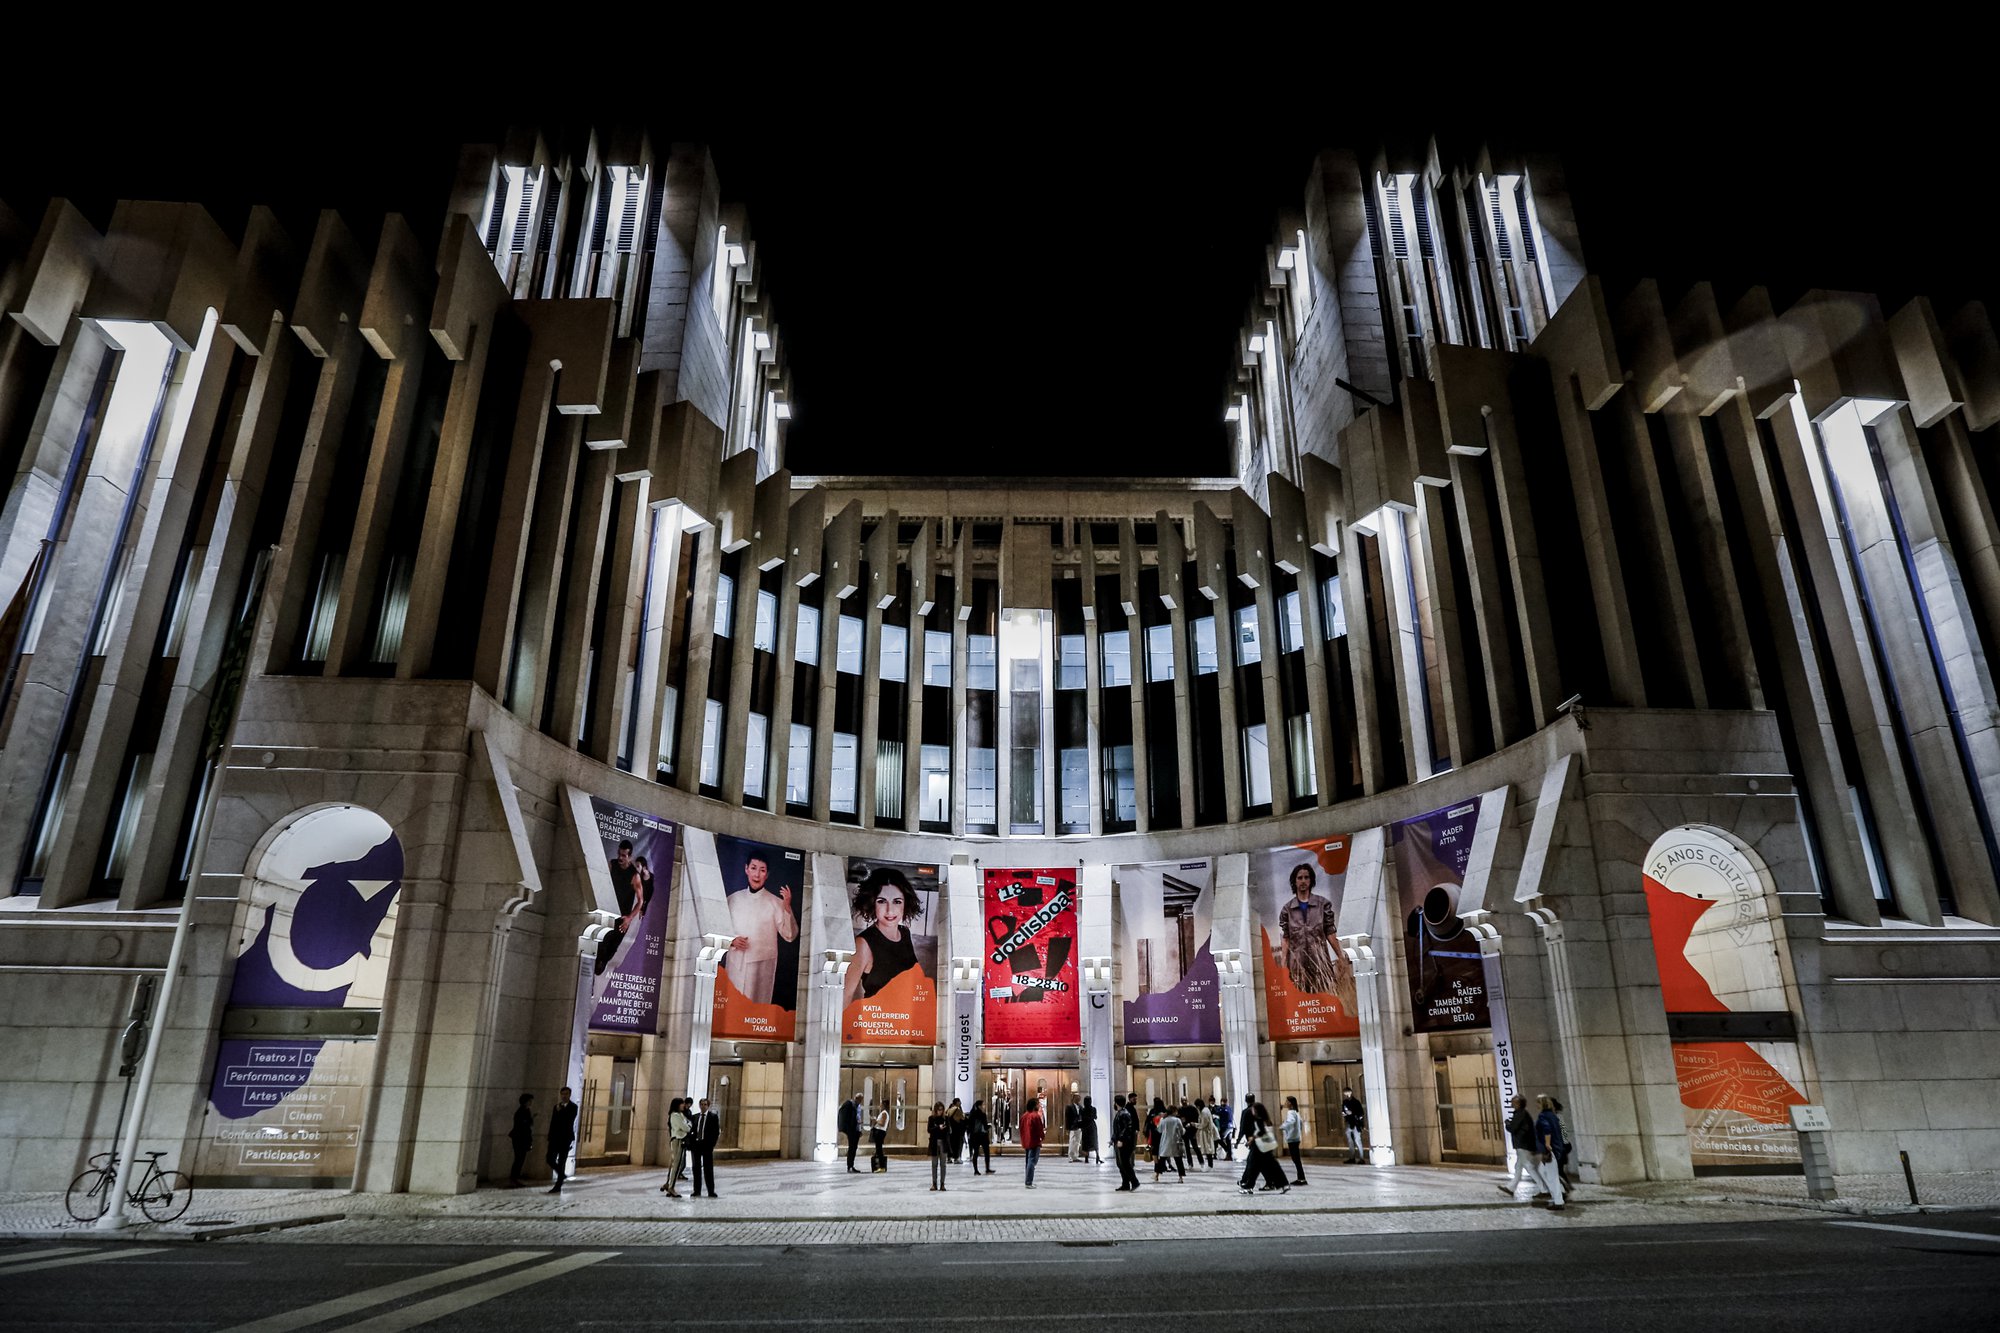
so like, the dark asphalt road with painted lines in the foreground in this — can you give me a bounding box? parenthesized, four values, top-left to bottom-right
(0, 1213, 2000, 1333)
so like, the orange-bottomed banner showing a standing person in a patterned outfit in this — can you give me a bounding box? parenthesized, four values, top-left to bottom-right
(1250, 835, 1362, 1041)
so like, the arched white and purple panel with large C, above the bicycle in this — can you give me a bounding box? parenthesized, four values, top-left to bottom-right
(194, 805, 402, 1185)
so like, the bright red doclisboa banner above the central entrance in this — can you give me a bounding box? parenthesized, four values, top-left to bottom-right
(984, 871, 1082, 1047)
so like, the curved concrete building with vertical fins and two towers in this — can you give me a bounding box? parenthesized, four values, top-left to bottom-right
(0, 134, 2000, 1193)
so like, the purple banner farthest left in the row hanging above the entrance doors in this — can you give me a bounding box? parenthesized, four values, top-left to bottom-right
(590, 797, 674, 1037)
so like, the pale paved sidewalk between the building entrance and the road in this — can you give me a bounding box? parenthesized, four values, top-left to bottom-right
(0, 1159, 2000, 1245)
